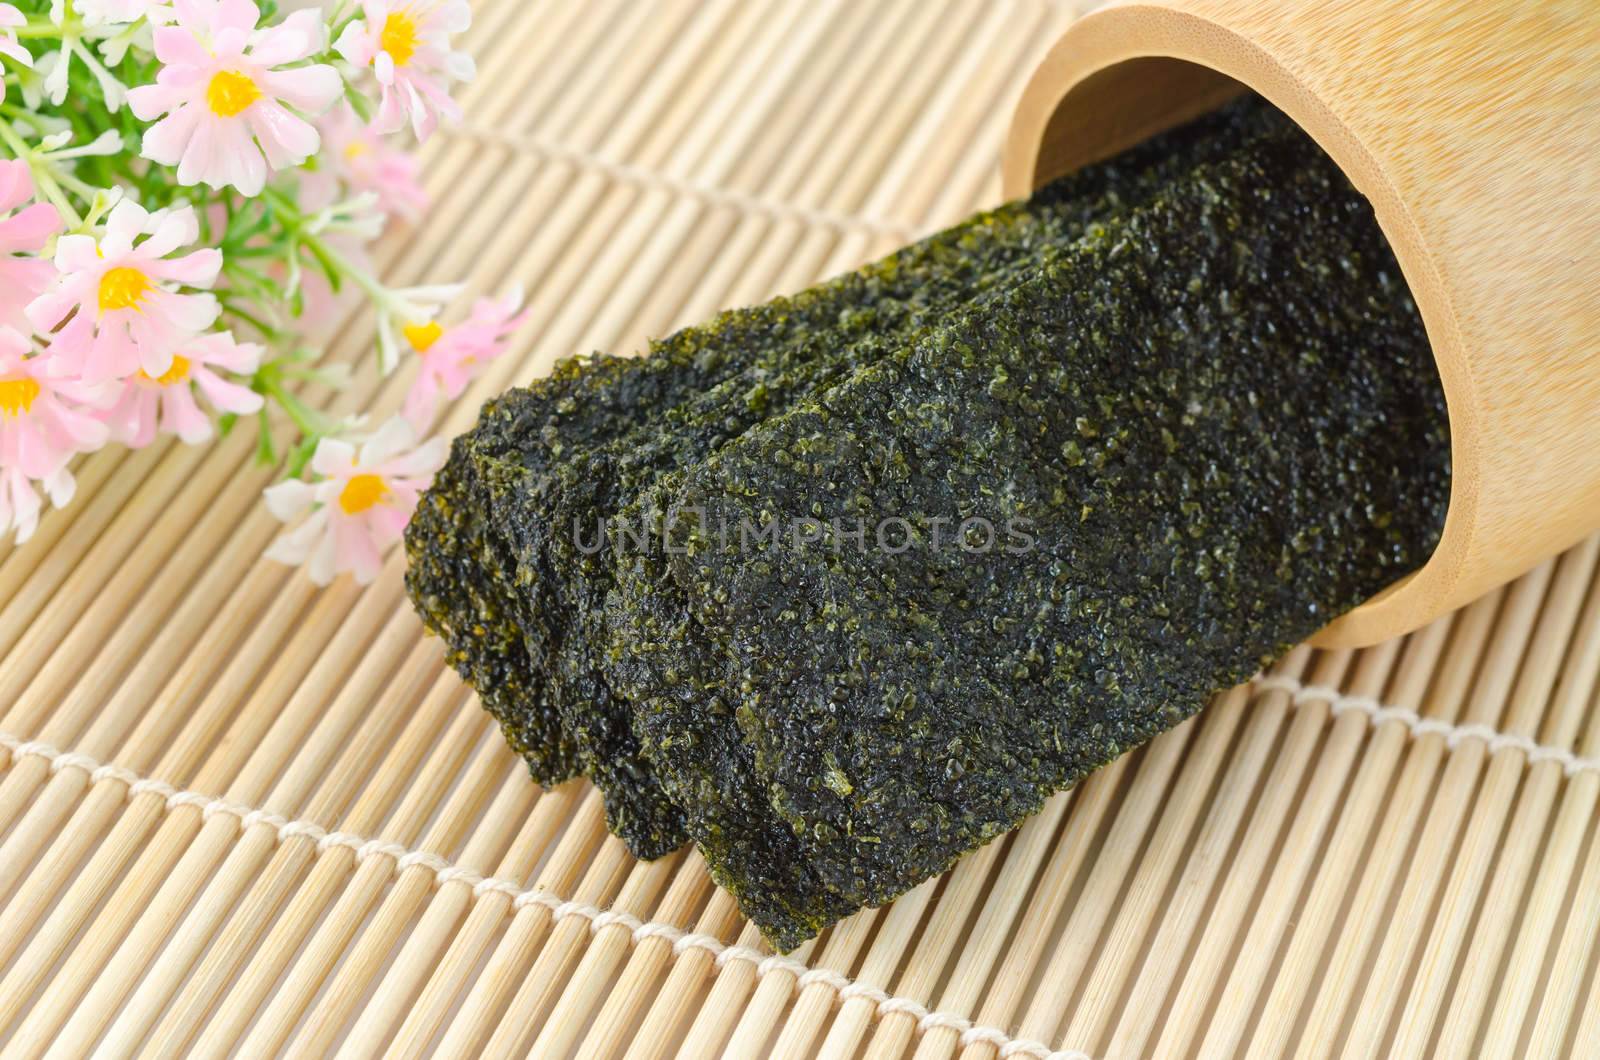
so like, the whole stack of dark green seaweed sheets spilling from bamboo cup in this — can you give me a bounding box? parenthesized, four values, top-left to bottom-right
(406, 99, 1450, 950)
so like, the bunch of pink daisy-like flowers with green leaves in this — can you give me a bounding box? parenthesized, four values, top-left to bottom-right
(0, 0, 522, 583)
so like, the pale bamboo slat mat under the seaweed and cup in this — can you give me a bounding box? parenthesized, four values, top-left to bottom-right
(0, 0, 1600, 1060)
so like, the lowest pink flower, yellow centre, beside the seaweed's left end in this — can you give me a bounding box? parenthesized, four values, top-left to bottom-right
(266, 416, 445, 584)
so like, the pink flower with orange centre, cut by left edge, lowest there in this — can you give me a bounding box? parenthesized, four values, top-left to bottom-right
(0, 328, 106, 544)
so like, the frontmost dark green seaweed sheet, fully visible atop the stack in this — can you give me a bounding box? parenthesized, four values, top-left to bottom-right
(642, 112, 1448, 948)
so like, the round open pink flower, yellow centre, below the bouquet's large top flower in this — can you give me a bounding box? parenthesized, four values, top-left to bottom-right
(27, 200, 222, 384)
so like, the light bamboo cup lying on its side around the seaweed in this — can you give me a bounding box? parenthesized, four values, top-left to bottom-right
(1003, 0, 1600, 647)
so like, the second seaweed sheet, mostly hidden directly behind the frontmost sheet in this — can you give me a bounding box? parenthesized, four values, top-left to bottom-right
(518, 99, 1292, 857)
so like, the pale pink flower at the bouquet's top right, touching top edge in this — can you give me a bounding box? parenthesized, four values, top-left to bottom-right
(334, 0, 475, 139)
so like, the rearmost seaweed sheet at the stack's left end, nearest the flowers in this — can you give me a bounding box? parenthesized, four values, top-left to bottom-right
(406, 208, 1049, 800)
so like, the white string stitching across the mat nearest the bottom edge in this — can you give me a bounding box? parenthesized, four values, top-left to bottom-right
(0, 732, 1090, 1060)
